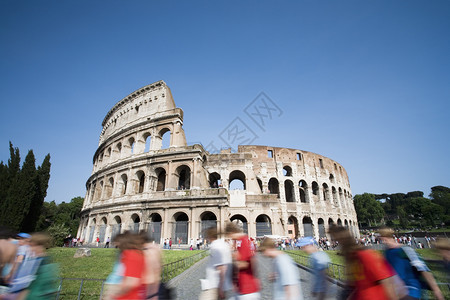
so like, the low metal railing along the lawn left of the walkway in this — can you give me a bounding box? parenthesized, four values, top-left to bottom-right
(55, 250, 209, 300)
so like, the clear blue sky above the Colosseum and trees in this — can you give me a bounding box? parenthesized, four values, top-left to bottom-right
(0, 0, 450, 202)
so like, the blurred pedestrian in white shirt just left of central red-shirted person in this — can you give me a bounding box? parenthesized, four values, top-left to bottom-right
(199, 227, 233, 300)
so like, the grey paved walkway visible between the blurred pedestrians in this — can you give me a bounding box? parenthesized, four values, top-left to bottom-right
(168, 254, 340, 300)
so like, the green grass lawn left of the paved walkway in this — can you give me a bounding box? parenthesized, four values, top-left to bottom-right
(48, 248, 206, 299)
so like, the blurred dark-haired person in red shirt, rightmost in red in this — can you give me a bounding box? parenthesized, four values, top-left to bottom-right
(330, 226, 397, 300)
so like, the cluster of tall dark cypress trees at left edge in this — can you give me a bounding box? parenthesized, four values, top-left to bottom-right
(0, 142, 50, 232)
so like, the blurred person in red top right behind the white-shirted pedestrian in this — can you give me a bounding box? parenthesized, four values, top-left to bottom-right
(225, 223, 261, 299)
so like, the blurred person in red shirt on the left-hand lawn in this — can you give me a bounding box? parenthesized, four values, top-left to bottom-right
(113, 233, 146, 300)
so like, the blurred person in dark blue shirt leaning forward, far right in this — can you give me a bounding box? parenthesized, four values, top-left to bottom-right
(379, 227, 444, 300)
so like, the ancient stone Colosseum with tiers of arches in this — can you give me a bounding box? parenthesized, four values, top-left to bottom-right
(78, 81, 358, 244)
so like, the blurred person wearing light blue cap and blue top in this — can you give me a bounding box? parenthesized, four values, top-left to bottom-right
(297, 237, 330, 300)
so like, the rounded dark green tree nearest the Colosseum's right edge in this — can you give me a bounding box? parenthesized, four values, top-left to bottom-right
(353, 193, 384, 224)
